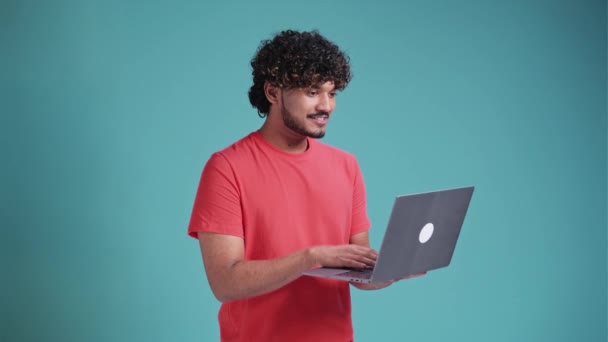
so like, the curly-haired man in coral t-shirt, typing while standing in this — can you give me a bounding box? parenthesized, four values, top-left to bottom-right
(188, 30, 408, 342)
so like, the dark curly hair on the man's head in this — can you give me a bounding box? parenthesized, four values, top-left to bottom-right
(249, 30, 352, 118)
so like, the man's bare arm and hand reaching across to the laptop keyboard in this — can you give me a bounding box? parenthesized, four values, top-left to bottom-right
(198, 233, 377, 302)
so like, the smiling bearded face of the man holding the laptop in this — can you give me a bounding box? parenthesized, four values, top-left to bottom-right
(281, 82, 336, 138)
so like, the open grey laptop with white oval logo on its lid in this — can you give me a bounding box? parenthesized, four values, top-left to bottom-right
(303, 186, 475, 283)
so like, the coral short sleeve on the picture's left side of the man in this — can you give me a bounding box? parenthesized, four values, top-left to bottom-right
(188, 153, 244, 238)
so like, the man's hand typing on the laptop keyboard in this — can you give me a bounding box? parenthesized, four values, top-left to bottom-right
(310, 244, 378, 268)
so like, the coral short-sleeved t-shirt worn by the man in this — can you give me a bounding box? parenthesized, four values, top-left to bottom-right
(188, 132, 370, 342)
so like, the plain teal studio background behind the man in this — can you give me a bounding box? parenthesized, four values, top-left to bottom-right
(0, 0, 607, 341)
